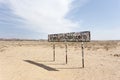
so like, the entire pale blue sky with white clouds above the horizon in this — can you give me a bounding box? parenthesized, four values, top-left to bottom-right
(0, 0, 120, 40)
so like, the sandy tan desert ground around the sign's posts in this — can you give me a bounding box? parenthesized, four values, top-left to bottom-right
(0, 41, 120, 80)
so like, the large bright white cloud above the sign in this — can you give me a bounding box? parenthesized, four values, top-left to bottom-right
(0, 0, 79, 33)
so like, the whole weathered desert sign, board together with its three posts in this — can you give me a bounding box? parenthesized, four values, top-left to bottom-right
(48, 31, 90, 68)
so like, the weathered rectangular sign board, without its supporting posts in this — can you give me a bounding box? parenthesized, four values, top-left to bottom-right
(48, 31, 90, 42)
